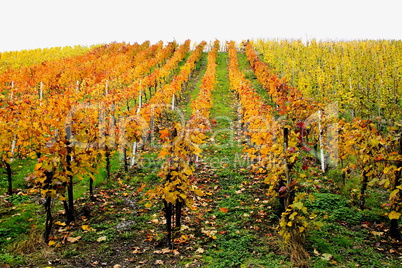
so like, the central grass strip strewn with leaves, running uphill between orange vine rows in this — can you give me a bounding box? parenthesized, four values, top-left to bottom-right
(190, 53, 286, 267)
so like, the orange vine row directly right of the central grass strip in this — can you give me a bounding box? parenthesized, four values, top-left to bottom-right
(229, 42, 308, 251)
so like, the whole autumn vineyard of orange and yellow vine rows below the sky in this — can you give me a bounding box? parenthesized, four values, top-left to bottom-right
(0, 40, 402, 268)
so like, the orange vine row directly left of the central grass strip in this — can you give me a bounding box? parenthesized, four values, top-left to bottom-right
(147, 41, 219, 245)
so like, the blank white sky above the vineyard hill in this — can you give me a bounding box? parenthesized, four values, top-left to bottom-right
(0, 0, 402, 52)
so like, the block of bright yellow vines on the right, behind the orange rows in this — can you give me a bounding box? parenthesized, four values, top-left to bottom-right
(255, 40, 402, 120)
